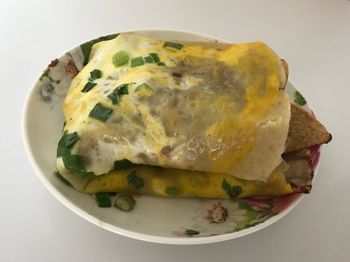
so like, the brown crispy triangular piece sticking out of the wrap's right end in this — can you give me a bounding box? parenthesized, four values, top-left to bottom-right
(285, 104, 332, 153)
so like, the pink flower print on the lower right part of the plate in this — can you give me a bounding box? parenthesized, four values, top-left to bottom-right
(172, 146, 320, 237)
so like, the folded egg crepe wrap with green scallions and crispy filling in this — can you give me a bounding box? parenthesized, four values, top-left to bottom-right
(57, 34, 331, 200)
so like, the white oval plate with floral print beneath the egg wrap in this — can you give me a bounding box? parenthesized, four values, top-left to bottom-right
(23, 30, 319, 244)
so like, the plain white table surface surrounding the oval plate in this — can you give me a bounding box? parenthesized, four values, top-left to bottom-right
(0, 0, 350, 262)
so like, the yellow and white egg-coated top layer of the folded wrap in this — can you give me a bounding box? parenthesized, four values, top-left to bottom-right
(59, 34, 290, 181)
